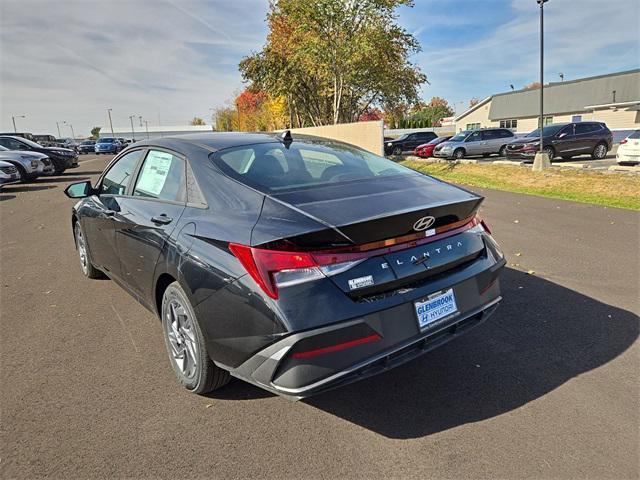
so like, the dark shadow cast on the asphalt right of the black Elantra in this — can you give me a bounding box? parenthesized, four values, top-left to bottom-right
(304, 269, 639, 439)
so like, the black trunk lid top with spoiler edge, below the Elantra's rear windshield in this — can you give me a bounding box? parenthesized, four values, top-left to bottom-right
(251, 174, 482, 249)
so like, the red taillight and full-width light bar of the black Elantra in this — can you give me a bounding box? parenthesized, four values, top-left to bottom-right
(229, 217, 484, 299)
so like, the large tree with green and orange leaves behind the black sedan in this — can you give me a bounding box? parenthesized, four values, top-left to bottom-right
(240, 0, 426, 126)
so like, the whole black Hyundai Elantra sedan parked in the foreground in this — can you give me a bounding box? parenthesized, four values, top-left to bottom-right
(65, 131, 505, 398)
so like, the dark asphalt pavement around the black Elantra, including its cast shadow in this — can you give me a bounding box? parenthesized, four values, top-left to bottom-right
(0, 156, 640, 479)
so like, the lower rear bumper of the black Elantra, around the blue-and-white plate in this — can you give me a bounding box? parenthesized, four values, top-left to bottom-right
(221, 259, 505, 399)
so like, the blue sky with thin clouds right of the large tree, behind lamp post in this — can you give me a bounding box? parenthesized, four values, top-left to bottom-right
(417, 0, 640, 101)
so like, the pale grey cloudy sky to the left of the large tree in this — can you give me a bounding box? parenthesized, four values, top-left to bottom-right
(0, 0, 268, 135)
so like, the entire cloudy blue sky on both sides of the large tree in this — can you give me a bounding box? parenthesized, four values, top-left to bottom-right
(0, 0, 640, 136)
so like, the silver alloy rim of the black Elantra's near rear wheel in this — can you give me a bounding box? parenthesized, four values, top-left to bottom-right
(164, 298, 199, 379)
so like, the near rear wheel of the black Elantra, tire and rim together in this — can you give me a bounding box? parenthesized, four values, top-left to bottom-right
(160, 282, 231, 394)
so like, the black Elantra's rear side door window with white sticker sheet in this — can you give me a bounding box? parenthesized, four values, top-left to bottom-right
(133, 150, 186, 202)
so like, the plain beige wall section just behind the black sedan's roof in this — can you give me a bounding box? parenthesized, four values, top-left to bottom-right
(291, 120, 384, 155)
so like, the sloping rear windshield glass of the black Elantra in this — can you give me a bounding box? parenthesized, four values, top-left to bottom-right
(213, 141, 415, 192)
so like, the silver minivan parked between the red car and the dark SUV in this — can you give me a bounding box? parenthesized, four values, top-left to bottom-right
(433, 128, 515, 160)
